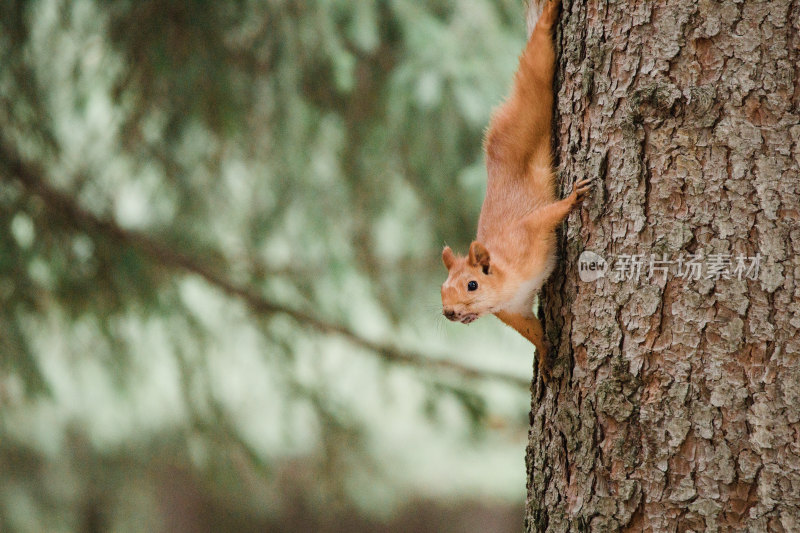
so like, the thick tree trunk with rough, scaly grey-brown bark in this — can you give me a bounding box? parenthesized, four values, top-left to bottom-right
(525, 0, 800, 532)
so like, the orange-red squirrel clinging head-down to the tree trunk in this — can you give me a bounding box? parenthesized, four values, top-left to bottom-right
(442, 0, 589, 379)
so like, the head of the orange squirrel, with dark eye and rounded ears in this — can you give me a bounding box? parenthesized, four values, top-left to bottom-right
(442, 241, 503, 324)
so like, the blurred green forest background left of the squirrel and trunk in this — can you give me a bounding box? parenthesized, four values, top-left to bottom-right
(0, 0, 532, 532)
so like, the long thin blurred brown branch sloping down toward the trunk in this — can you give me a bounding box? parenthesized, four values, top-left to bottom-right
(0, 139, 530, 388)
